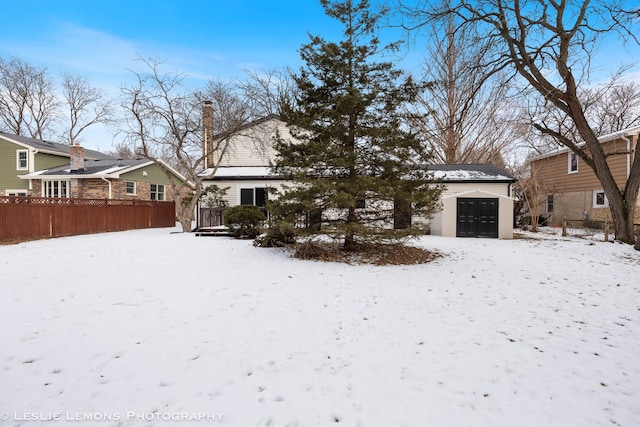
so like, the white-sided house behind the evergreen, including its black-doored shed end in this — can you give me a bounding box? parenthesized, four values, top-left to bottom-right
(203, 116, 516, 239)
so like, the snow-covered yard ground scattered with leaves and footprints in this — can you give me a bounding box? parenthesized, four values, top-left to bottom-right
(0, 229, 640, 427)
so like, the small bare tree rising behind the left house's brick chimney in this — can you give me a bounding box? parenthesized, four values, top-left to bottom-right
(61, 73, 113, 145)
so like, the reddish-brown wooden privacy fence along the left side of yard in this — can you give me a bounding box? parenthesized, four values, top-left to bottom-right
(0, 196, 176, 243)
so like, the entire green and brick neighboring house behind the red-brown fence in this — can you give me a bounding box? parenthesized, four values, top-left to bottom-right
(0, 132, 190, 201)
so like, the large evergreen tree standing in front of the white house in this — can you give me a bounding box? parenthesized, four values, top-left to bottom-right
(274, 0, 441, 250)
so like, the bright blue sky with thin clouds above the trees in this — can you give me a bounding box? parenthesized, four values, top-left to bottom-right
(0, 0, 640, 152)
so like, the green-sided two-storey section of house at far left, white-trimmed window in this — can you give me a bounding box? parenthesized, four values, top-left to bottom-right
(0, 132, 113, 196)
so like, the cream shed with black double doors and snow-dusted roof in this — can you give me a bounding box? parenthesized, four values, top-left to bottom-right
(428, 165, 516, 239)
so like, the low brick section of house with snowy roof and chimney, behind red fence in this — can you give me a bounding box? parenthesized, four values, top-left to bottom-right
(20, 145, 190, 201)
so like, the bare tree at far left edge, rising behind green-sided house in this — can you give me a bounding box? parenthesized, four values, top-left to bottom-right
(0, 57, 59, 139)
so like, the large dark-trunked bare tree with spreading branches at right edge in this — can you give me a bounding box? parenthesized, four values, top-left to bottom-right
(406, 0, 640, 246)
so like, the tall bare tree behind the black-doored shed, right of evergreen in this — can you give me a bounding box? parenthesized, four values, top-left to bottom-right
(412, 15, 514, 166)
